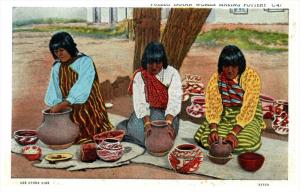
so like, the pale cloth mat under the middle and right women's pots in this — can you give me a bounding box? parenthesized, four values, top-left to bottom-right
(131, 121, 288, 180)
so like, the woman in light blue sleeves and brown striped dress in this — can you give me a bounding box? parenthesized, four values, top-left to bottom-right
(45, 32, 114, 143)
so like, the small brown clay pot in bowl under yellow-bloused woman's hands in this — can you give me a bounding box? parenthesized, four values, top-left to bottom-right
(207, 137, 233, 165)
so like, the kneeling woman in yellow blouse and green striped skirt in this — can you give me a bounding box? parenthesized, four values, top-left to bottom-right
(194, 45, 265, 153)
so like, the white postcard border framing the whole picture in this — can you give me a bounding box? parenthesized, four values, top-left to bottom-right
(0, 0, 300, 192)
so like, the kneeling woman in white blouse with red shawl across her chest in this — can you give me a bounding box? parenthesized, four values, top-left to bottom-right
(117, 42, 182, 147)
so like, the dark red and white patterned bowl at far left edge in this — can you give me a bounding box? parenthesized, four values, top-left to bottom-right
(14, 129, 38, 145)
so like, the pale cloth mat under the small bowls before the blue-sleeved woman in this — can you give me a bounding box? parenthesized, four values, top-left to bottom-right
(11, 114, 145, 171)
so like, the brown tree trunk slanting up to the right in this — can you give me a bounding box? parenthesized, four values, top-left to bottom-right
(161, 8, 211, 70)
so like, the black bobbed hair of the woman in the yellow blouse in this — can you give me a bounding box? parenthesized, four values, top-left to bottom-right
(218, 45, 246, 75)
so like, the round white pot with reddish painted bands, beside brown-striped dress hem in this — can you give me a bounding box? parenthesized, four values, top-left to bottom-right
(97, 138, 124, 162)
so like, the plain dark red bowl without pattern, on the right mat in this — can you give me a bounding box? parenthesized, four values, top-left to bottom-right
(238, 152, 265, 171)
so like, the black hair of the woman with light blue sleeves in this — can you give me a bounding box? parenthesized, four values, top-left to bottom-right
(49, 32, 78, 59)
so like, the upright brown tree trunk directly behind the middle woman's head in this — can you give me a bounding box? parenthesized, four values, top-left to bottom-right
(133, 8, 161, 70)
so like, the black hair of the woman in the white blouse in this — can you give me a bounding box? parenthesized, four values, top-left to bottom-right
(141, 42, 168, 69)
